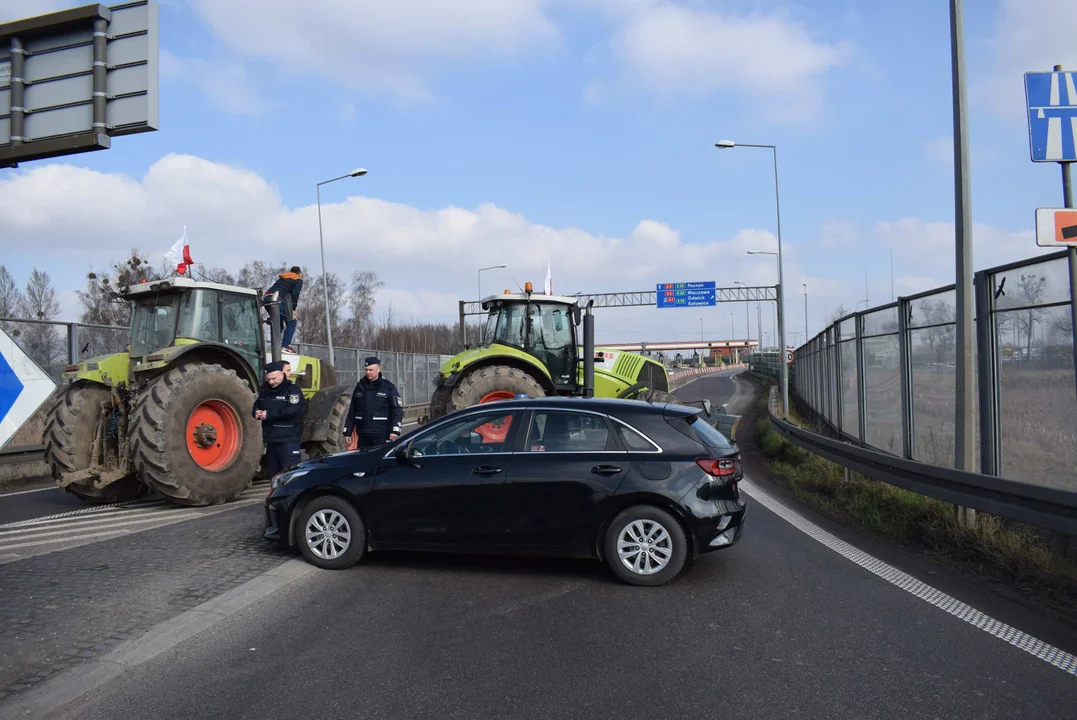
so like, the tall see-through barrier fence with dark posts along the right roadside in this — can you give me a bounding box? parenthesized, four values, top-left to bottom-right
(784, 251, 1077, 493)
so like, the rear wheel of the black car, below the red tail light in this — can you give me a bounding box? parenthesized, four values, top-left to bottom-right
(603, 505, 688, 588)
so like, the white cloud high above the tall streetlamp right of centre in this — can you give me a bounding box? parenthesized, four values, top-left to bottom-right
(603, 0, 851, 124)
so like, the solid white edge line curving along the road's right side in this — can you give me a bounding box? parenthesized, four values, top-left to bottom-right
(740, 481, 1077, 675)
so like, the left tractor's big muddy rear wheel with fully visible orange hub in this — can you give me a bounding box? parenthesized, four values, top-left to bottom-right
(130, 364, 262, 506)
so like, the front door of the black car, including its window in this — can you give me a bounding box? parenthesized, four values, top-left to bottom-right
(370, 409, 523, 547)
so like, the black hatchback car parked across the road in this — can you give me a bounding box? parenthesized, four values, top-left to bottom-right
(265, 397, 744, 585)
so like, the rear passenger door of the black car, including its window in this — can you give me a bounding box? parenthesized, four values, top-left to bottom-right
(501, 409, 631, 548)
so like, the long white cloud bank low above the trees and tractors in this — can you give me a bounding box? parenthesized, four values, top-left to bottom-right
(0, 154, 815, 341)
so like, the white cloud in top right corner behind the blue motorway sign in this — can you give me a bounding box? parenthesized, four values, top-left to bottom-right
(970, 0, 1077, 123)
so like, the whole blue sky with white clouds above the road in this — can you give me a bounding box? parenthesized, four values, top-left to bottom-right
(0, 0, 1077, 344)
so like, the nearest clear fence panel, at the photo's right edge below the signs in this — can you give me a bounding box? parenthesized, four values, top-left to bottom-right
(990, 258, 1077, 491)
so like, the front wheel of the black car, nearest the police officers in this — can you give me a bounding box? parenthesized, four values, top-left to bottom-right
(295, 495, 366, 570)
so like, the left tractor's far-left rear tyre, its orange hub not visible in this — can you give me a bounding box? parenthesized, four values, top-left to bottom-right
(44, 382, 146, 503)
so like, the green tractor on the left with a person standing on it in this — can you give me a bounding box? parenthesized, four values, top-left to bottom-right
(44, 277, 352, 506)
